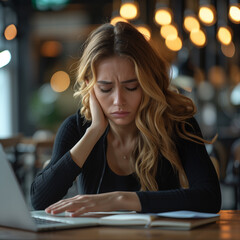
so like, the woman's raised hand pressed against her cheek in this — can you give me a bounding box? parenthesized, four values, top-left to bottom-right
(89, 89, 108, 135)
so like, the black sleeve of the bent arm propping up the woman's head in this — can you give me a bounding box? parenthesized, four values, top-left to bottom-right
(30, 113, 85, 210)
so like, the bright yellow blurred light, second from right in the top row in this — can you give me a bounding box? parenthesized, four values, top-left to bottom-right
(198, 4, 216, 26)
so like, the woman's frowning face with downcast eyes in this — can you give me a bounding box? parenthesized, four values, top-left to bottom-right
(94, 56, 142, 126)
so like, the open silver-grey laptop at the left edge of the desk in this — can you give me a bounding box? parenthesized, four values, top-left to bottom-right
(0, 144, 100, 232)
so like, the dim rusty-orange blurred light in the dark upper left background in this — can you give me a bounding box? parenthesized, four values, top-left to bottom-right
(40, 41, 62, 57)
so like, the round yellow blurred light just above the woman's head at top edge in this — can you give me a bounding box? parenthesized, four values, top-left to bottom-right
(120, 0, 139, 20)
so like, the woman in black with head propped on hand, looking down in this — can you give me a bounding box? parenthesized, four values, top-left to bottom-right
(31, 22, 221, 217)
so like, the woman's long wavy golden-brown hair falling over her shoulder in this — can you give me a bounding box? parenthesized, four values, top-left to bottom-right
(74, 22, 214, 191)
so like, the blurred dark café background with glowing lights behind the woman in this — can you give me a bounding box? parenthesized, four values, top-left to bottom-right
(0, 0, 240, 209)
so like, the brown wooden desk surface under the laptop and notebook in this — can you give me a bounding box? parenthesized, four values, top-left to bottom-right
(0, 210, 240, 240)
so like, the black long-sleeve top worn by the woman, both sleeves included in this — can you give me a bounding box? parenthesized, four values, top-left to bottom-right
(31, 112, 221, 212)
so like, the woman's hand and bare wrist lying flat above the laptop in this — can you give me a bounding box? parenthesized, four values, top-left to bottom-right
(45, 192, 141, 217)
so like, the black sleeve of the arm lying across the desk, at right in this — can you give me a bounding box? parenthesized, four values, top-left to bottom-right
(137, 118, 221, 212)
